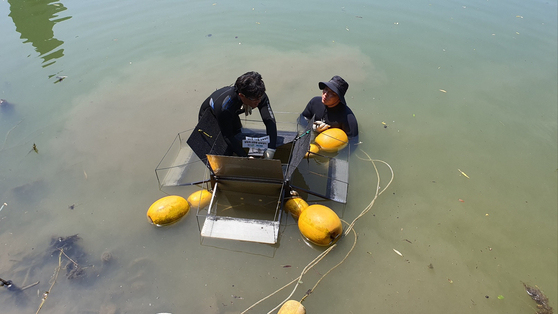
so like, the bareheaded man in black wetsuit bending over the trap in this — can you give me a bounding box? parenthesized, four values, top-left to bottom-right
(198, 72, 277, 159)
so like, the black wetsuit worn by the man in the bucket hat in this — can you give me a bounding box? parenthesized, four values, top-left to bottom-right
(301, 96, 358, 138)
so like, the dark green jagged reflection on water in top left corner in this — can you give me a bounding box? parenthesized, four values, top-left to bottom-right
(8, 0, 71, 68)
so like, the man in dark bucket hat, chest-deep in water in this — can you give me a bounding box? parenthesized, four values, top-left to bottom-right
(301, 75, 358, 138)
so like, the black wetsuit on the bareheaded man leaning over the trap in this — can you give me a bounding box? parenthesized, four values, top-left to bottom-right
(198, 86, 277, 157)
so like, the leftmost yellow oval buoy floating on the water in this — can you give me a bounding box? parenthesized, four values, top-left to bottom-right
(147, 195, 190, 227)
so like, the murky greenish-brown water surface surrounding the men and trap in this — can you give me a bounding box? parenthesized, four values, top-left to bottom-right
(0, 0, 558, 313)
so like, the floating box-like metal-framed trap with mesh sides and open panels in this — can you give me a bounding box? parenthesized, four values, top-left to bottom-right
(155, 113, 349, 244)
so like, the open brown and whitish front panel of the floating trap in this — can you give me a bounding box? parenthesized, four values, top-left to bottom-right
(201, 155, 284, 244)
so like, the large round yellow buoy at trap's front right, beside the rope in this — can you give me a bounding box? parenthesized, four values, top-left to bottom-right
(298, 204, 343, 246)
